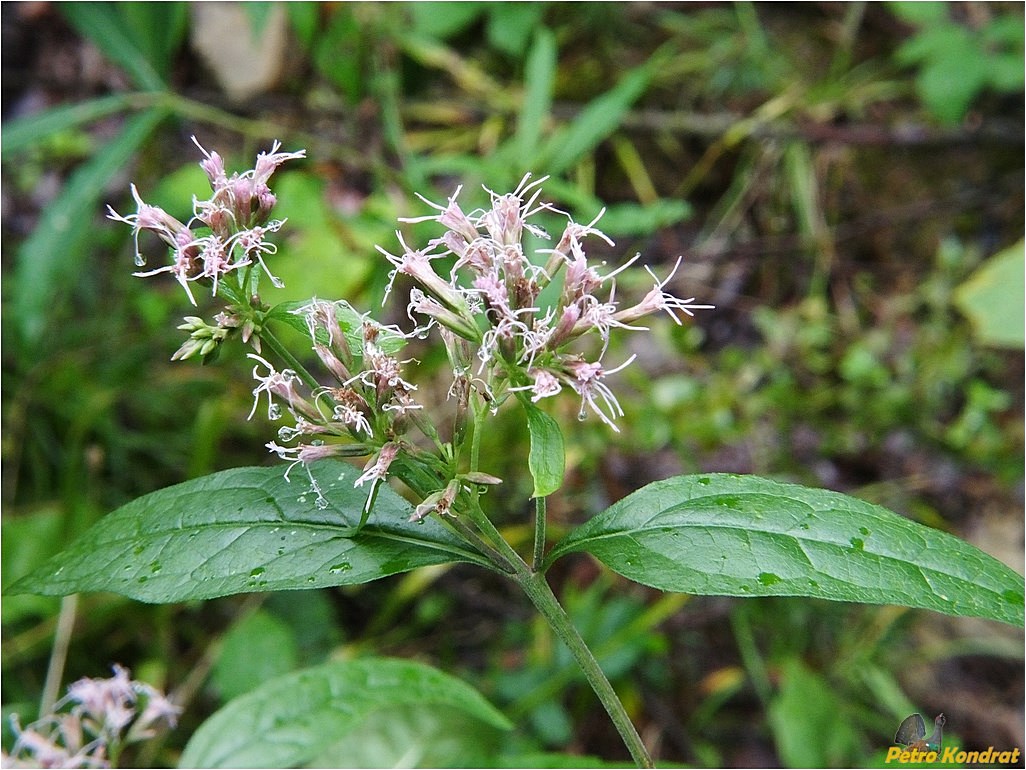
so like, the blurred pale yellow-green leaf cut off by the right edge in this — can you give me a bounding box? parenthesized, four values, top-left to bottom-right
(955, 240, 1026, 350)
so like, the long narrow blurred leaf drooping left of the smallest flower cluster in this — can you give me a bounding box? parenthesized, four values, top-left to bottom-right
(12, 108, 165, 348)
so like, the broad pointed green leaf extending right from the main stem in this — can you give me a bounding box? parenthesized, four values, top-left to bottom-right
(546, 473, 1024, 626)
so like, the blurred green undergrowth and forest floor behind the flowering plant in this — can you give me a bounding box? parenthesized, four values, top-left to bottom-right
(0, 2, 1024, 766)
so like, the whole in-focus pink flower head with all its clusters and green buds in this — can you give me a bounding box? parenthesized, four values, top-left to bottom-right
(110, 139, 711, 517)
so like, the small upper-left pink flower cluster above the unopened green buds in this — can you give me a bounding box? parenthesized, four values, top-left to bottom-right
(108, 137, 306, 305)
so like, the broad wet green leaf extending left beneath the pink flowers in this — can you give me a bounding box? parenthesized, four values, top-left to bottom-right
(9, 460, 486, 602)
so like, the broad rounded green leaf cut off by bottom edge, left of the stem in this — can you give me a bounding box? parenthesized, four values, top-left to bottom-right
(180, 658, 512, 767)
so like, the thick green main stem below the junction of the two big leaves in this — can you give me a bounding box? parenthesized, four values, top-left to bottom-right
(513, 562, 656, 767)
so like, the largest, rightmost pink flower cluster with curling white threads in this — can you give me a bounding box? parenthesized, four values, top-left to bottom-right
(379, 175, 712, 430)
